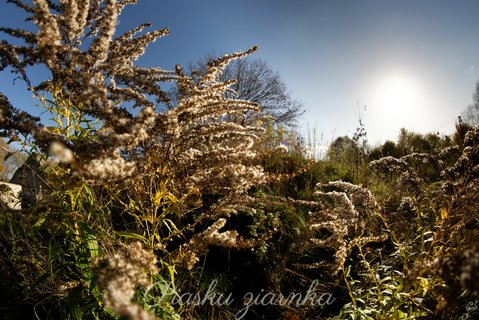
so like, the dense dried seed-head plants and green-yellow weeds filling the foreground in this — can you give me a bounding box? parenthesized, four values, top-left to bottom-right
(0, 0, 479, 320)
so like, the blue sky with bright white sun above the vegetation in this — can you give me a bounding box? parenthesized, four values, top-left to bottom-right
(0, 0, 479, 144)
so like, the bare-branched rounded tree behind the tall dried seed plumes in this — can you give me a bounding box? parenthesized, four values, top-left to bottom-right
(184, 56, 304, 125)
